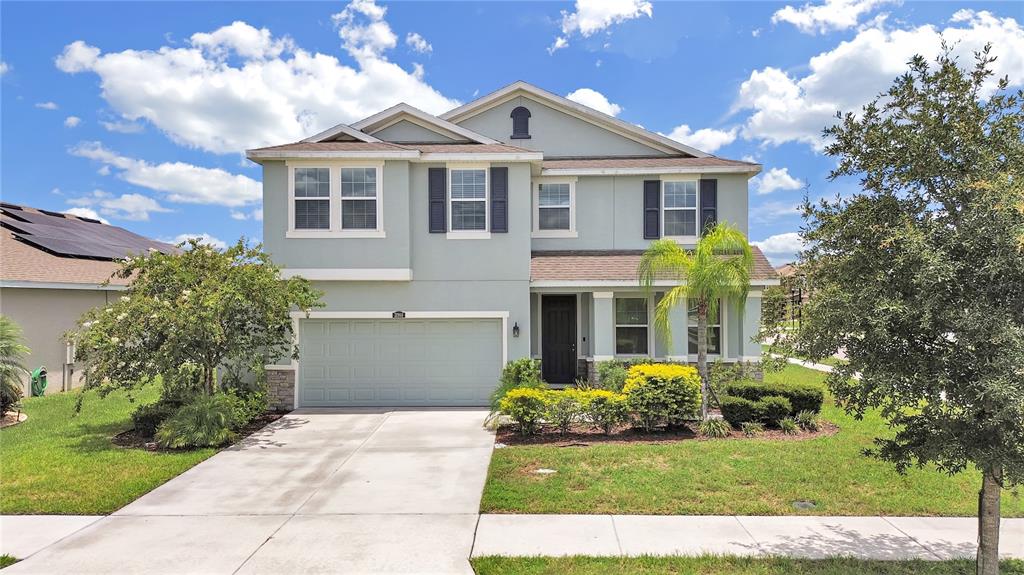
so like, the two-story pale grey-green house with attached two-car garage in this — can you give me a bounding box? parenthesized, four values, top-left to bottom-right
(247, 82, 778, 406)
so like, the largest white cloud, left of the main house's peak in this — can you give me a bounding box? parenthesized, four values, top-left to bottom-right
(56, 0, 459, 153)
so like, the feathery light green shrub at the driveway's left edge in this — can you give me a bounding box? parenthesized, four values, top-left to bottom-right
(157, 393, 237, 449)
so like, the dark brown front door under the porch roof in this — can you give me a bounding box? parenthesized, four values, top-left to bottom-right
(541, 296, 577, 384)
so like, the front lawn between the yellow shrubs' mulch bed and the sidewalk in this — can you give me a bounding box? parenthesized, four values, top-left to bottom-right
(480, 365, 1024, 517)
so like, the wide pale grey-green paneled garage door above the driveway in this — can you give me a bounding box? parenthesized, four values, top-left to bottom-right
(299, 318, 502, 407)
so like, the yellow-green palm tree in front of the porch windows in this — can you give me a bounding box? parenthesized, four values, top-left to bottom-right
(637, 222, 754, 419)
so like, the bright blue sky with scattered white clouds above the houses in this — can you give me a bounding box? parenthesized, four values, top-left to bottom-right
(0, 0, 1024, 263)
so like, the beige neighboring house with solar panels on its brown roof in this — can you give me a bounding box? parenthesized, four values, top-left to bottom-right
(0, 204, 174, 393)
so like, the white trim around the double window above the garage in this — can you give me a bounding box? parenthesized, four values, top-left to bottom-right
(285, 161, 387, 239)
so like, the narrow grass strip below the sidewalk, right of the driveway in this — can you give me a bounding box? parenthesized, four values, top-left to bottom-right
(471, 556, 1024, 575)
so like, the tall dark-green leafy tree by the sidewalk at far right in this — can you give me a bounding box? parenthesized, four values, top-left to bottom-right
(798, 47, 1024, 575)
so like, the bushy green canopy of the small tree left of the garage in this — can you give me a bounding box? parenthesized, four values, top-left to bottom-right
(70, 238, 323, 395)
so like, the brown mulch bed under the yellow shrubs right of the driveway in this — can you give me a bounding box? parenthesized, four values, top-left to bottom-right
(495, 422, 839, 447)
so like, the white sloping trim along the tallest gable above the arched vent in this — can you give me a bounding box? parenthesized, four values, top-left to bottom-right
(439, 80, 711, 158)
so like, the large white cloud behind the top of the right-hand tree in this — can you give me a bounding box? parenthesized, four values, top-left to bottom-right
(734, 10, 1024, 150)
